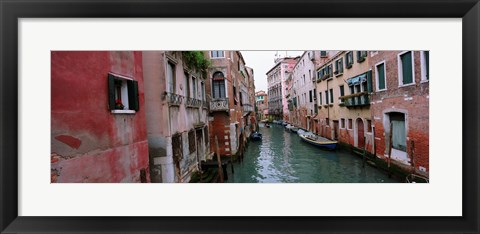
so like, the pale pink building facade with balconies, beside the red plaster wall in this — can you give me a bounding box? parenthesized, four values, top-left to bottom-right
(143, 51, 210, 183)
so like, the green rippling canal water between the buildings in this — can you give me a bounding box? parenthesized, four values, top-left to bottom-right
(227, 124, 399, 183)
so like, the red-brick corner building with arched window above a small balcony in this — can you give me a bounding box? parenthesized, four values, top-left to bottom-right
(205, 51, 254, 156)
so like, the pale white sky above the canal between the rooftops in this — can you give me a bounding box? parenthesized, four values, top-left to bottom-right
(240, 50, 303, 92)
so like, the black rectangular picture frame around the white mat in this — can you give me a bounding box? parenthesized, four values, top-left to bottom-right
(0, 0, 480, 233)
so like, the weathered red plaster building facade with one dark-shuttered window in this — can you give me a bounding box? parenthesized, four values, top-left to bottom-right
(51, 51, 150, 183)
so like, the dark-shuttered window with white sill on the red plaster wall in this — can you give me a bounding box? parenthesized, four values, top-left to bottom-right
(108, 74, 139, 113)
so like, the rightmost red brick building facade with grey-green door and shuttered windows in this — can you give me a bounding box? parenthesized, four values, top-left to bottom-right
(369, 51, 430, 177)
